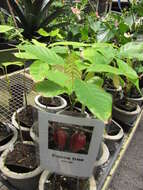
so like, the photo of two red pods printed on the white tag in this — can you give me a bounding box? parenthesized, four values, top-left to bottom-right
(48, 121, 93, 154)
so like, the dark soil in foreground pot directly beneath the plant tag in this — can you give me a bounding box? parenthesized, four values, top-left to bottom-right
(44, 174, 89, 190)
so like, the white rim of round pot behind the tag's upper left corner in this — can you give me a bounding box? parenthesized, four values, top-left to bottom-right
(35, 95, 67, 113)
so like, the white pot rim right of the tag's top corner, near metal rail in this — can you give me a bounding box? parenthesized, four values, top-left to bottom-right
(103, 119, 124, 141)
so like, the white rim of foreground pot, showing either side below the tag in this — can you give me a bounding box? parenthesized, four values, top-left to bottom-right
(38, 170, 97, 190)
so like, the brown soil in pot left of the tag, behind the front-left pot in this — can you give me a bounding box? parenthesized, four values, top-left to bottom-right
(17, 105, 38, 128)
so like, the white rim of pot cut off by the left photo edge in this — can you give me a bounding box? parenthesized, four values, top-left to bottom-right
(0, 122, 18, 152)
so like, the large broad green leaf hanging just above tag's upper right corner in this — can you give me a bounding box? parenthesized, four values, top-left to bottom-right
(74, 79, 112, 121)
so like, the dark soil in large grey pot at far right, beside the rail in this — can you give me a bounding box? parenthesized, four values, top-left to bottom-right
(114, 99, 137, 112)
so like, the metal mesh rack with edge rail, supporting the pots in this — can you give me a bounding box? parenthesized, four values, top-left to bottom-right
(0, 71, 142, 190)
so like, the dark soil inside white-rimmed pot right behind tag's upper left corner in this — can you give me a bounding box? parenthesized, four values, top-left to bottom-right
(39, 96, 61, 107)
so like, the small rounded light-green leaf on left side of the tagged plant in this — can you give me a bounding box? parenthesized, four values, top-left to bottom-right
(30, 60, 49, 82)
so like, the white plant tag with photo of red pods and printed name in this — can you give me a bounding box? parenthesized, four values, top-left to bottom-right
(38, 110, 104, 177)
